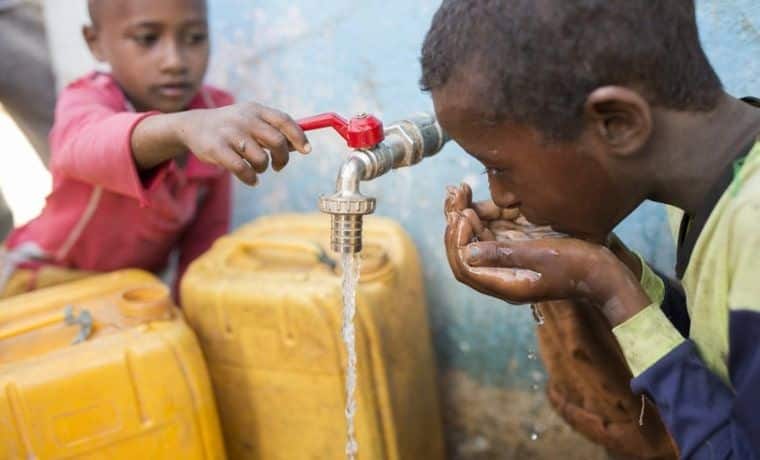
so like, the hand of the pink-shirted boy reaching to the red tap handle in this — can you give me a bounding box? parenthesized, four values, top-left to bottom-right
(176, 102, 311, 185)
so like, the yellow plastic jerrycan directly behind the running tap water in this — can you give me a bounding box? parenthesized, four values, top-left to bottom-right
(182, 215, 444, 460)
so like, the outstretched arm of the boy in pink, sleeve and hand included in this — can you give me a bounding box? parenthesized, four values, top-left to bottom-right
(50, 79, 310, 206)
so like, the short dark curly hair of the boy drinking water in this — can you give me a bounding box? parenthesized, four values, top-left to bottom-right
(421, 0, 722, 141)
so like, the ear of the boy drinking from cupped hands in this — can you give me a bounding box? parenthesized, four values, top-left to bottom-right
(584, 86, 652, 156)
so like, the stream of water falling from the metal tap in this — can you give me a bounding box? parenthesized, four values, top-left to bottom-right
(342, 254, 360, 460)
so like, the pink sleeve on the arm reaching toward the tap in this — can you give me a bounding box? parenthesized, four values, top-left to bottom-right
(50, 82, 169, 206)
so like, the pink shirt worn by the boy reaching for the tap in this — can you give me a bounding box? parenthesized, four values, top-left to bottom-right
(6, 73, 233, 284)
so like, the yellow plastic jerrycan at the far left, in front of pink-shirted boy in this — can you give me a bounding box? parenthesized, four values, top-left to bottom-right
(0, 270, 225, 460)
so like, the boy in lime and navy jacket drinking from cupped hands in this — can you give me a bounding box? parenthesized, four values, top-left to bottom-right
(422, 0, 760, 459)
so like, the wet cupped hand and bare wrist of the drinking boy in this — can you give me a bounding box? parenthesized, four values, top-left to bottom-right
(445, 207, 651, 326)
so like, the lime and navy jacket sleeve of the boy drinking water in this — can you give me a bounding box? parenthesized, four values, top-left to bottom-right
(615, 205, 760, 459)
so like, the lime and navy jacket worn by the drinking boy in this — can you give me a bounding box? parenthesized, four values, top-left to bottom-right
(613, 127, 760, 460)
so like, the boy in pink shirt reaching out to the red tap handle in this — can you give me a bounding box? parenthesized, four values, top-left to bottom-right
(0, 0, 310, 297)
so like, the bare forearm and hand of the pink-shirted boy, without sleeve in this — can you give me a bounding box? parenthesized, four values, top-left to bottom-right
(131, 103, 310, 185)
